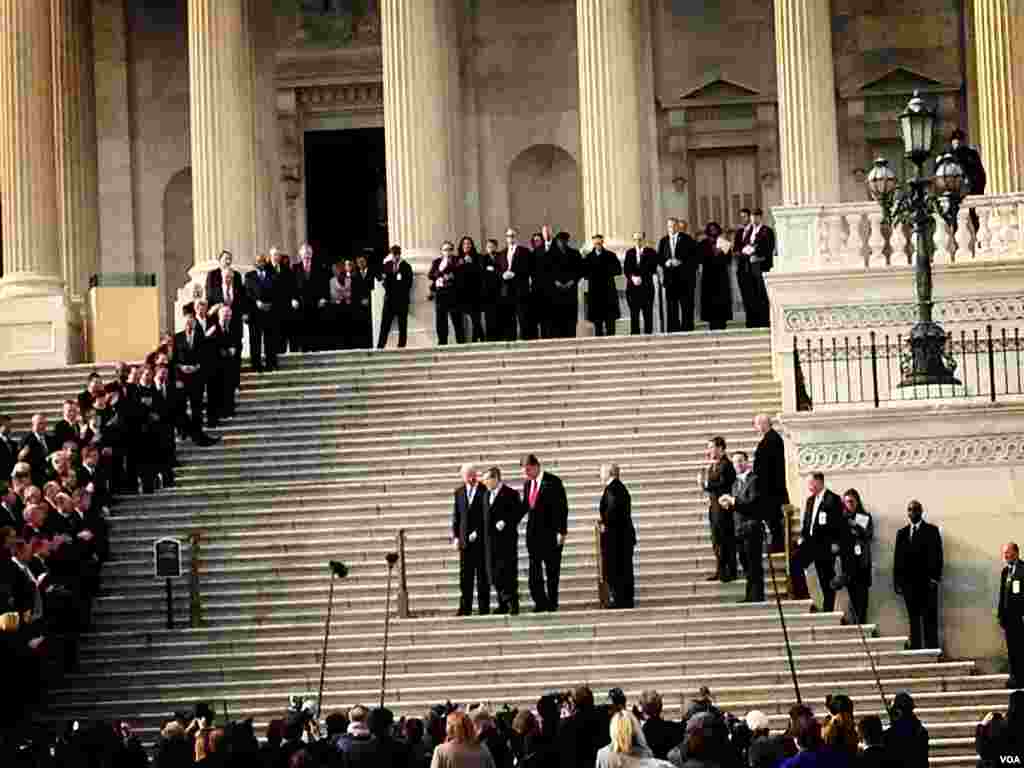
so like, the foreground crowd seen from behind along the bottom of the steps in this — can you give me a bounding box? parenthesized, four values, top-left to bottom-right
(22, 686, 1024, 768)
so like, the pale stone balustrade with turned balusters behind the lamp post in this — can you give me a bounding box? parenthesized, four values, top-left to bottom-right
(773, 193, 1024, 271)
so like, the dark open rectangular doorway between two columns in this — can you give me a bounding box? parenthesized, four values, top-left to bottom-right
(305, 128, 388, 265)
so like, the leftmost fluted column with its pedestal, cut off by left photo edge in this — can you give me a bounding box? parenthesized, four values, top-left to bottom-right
(0, 0, 81, 368)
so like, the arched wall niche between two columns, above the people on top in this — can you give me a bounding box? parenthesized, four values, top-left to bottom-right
(509, 144, 587, 241)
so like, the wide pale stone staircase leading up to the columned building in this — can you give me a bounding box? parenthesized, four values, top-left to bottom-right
(0, 331, 1007, 766)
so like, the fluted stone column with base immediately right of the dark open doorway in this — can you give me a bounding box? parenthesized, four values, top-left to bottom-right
(381, 0, 458, 346)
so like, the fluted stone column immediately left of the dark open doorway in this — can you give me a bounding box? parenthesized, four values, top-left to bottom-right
(188, 0, 260, 284)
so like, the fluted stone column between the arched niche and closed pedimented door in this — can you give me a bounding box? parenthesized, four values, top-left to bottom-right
(577, 0, 649, 250)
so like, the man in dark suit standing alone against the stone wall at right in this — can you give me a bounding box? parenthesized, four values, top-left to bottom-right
(893, 500, 942, 649)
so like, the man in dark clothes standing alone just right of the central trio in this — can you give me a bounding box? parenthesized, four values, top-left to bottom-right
(598, 464, 637, 608)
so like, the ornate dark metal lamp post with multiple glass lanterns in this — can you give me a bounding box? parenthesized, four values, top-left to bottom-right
(867, 92, 965, 387)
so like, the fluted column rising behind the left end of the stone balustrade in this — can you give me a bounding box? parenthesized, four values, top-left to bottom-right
(775, 0, 840, 205)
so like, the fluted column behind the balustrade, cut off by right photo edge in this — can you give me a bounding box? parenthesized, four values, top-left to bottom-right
(974, 0, 1024, 195)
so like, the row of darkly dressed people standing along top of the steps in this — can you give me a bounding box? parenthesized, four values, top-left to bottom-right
(199, 208, 775, 371)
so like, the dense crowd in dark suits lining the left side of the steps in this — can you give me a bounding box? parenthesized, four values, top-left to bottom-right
(0, 319, 241, 723)
